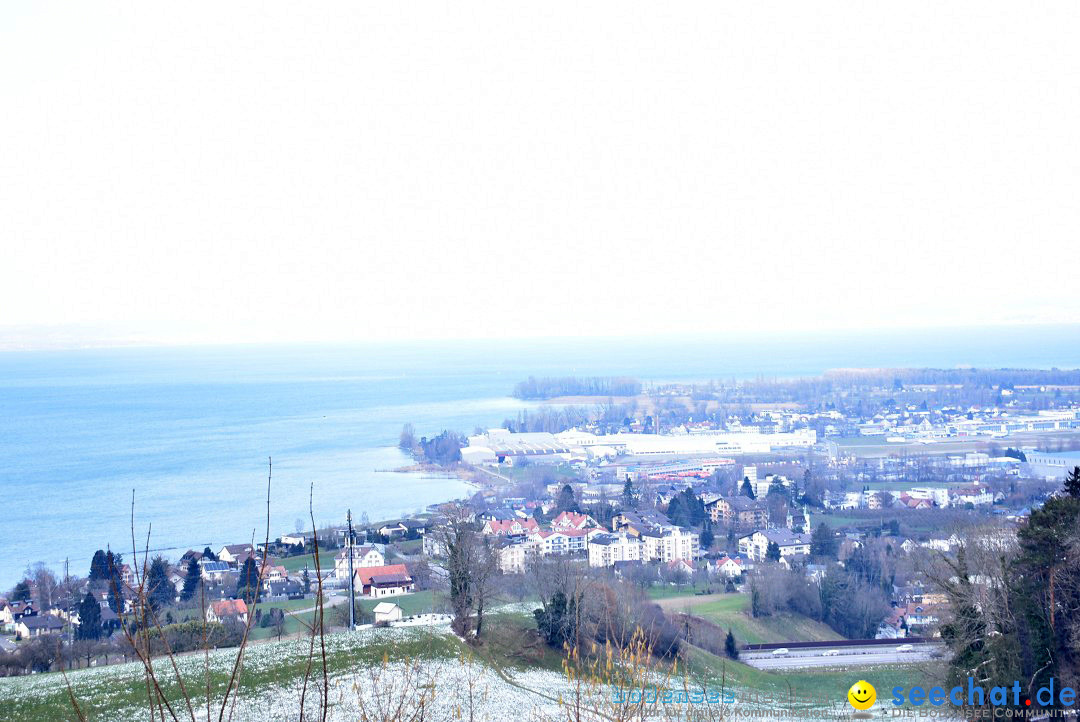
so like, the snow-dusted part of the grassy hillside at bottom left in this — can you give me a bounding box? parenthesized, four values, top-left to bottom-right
(0, 626, 566, 722)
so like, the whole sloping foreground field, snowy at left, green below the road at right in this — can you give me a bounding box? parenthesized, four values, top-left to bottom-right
(0, 627, 937, 722)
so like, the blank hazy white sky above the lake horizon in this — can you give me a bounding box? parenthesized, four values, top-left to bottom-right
(0, 0, 1080, 343)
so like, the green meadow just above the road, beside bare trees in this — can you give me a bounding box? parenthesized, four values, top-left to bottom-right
(662, 594, 843, 644)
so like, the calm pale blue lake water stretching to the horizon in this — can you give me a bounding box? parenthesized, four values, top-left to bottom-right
(0, 326, 1080, 589)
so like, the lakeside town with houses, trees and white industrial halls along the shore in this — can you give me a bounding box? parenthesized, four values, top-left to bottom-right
(0, 370, 1080, 686)
